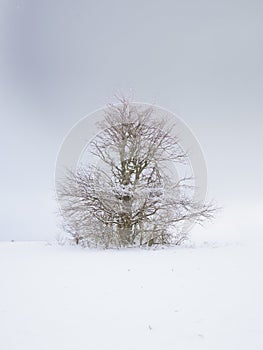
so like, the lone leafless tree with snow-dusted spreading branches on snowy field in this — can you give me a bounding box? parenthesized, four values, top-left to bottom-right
(58, 98, 214, 247)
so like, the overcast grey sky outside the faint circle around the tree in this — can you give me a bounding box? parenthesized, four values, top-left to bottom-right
(0, 0, 263, 240)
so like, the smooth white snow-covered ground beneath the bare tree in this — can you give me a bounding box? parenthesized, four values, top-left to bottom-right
(0, 230, 263, 350)
